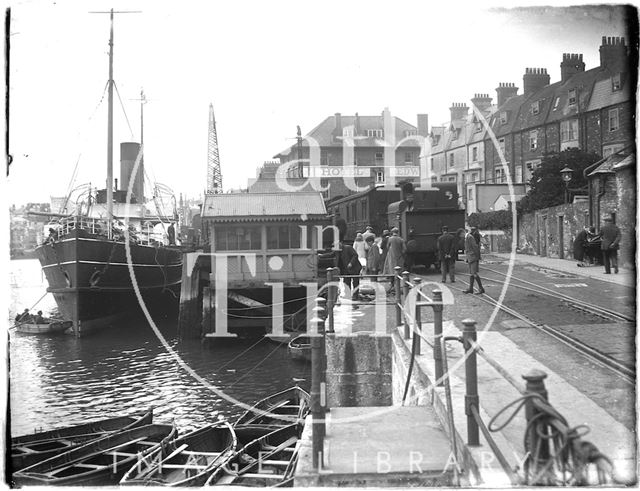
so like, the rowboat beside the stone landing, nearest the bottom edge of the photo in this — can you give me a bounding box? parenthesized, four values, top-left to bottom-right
(206, 424, 300, 487)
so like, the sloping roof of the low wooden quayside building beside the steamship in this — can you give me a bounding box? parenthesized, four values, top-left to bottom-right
(202, 192, 327, 219)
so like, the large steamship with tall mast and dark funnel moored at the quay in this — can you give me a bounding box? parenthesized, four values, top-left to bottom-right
(36, 10, 182, 335)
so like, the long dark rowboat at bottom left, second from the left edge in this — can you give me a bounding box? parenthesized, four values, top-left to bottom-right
(12, 424, 177, 486)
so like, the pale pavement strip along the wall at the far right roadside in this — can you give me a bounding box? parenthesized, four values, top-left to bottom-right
(490, 252, 637, 287)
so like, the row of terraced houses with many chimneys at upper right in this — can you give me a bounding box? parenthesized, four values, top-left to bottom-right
(430, 37, 635, 213)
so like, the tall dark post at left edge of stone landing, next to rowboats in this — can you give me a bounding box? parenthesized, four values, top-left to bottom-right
(310, 317, 325, 469)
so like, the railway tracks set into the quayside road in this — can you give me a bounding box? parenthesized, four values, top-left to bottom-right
(423, 268, 636, 386)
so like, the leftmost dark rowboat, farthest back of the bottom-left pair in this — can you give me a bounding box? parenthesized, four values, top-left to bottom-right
(11, 410, 153, 472)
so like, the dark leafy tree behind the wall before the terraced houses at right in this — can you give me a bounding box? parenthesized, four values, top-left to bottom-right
(517, 148, 600, 213)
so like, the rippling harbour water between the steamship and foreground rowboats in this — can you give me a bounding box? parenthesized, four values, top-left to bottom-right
(8, 259, 311, 436)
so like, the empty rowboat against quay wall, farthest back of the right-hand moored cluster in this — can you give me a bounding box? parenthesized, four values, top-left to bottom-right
(235, 386, 310, 426)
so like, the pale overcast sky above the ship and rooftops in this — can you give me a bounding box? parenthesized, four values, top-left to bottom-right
(5, 0, 625, 208)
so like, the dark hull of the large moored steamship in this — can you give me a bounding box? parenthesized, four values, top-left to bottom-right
(36, 229, 182, 333)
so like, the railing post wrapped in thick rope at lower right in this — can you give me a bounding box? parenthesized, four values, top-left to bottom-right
(522, 368, 549, 485)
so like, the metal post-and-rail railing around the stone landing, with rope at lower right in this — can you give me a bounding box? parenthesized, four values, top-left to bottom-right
(311, 267, 615, 485)
